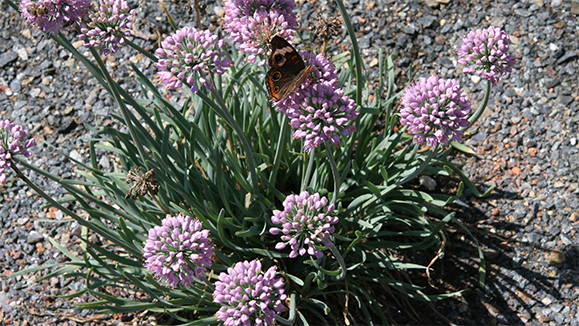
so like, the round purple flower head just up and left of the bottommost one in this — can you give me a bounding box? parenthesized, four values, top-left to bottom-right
(143, 214, 214, 287)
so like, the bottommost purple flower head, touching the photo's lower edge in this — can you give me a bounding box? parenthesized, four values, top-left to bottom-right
(213, 260, 287, 326)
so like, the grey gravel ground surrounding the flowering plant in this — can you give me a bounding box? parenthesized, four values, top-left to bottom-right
(0, 0, 579, 326)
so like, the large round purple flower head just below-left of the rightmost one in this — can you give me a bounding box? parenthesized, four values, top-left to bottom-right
(400, 75, 471, 147)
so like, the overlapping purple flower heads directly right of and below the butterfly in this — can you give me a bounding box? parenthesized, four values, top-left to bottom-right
(276, 52, 359, 151)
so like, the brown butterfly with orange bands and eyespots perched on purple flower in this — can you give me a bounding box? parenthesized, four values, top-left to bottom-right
(265, 35, 314, 102)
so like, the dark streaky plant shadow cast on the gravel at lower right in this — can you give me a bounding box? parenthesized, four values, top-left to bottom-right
(388, 183, 578, 325)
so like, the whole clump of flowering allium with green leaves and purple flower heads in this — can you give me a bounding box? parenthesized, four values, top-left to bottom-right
(5, 0, 512, 325)
